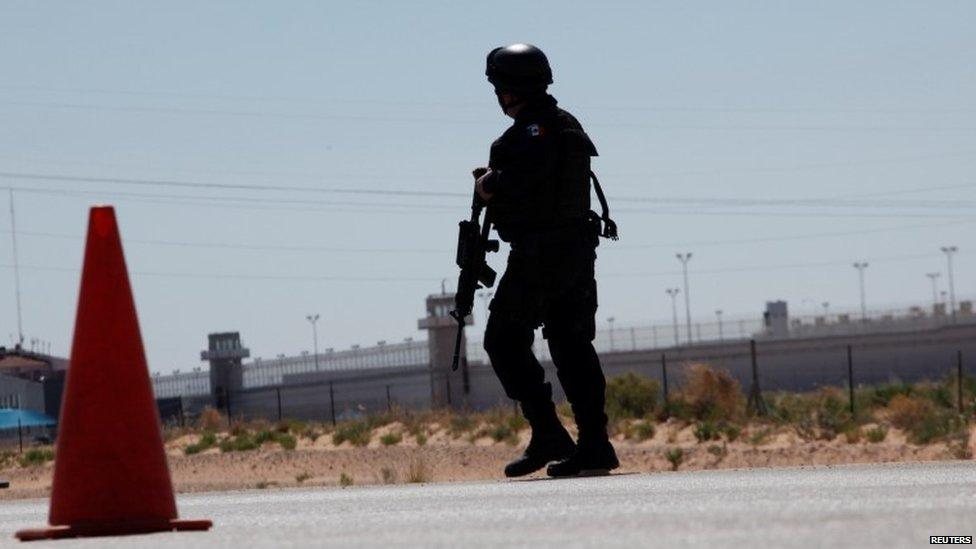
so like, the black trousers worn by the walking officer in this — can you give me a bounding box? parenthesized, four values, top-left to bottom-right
(484, 233, 607, 436)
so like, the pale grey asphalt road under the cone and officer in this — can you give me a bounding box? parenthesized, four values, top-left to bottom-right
(0, 462, 976, 549)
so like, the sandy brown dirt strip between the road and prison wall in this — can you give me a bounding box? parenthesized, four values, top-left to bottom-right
(0, 423, 976, 499)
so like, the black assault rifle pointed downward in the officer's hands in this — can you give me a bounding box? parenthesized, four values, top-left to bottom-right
(451, 168, 498, 371)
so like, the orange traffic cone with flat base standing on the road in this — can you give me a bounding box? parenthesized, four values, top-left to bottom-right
(17, 206, 211, 541)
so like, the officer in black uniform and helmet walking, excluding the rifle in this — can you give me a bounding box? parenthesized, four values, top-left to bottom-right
(475, 44, 619, 477)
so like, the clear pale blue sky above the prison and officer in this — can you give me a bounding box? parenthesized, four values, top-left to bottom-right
(0, 1, 976, 371)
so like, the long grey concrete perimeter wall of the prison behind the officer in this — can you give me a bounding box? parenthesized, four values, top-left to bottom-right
(156, 325, 976, 421)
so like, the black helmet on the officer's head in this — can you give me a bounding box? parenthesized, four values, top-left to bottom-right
(485, 44, 552, 93)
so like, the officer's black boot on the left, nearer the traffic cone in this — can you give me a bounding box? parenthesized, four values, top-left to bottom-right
(505, 390, 576, 477)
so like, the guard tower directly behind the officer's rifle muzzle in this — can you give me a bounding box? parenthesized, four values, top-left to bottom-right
(417, 293, 474, 408)
